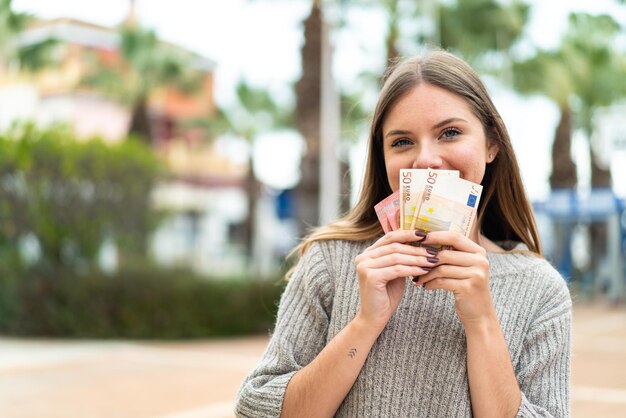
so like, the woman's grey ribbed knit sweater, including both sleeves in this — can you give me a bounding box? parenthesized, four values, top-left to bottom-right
(236, 241, 571, 418)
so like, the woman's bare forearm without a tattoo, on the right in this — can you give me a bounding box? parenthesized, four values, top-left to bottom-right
(465, 314, 521, 418)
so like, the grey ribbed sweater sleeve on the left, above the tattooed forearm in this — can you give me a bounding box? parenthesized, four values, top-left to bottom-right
(235, 243, 333, 418)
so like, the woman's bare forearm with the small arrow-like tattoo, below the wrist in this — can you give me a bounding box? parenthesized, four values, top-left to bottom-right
(281, 316, 380, 417)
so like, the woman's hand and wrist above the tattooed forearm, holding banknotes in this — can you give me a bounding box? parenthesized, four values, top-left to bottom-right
(355, 230, 437, 332)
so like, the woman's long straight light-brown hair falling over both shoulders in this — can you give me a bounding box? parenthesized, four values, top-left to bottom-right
(294, 50, 543, 264)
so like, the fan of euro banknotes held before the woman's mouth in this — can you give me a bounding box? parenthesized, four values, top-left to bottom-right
(374, 169, 483, 236)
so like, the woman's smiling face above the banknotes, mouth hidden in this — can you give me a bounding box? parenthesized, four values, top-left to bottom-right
(383, 83, 498, 191)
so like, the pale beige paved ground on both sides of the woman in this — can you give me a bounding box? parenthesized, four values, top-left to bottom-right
(0, 304, 626, 418)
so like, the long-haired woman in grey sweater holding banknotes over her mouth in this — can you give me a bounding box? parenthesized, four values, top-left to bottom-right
(236, 51, 571, 417)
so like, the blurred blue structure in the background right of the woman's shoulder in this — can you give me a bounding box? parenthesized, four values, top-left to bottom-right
(533, 189, 626, 301)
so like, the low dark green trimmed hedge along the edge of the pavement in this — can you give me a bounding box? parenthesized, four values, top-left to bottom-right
(0, 268, 285, 339)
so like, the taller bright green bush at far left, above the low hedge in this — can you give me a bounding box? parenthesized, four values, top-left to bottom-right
(0, 123, 167, 270)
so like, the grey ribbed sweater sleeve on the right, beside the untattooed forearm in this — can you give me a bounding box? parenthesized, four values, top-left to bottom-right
(516, 262, 572, 418)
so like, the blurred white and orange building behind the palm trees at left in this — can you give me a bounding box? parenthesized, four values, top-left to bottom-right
(0, 15, 247, 273)
